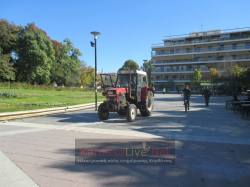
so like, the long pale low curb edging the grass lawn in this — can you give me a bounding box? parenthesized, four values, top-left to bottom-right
(0, 102, 101, 121)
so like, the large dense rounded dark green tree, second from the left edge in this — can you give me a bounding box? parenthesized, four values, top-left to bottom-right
(17, 24, 55, 84)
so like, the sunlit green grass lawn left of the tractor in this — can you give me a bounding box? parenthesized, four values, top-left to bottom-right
(0, 87, 104, 112)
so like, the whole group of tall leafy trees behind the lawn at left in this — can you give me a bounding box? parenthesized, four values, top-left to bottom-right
(0, 20, 84, 85)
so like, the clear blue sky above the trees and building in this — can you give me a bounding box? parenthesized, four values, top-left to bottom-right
(0, 0, 250, 72)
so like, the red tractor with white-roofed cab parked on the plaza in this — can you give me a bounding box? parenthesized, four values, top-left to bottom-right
(98, 70, 154, 121)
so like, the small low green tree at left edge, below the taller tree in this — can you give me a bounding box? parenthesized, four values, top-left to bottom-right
(0, 54, 15, 82)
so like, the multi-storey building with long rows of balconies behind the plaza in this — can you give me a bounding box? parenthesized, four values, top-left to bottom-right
(152, 29, 250, 88)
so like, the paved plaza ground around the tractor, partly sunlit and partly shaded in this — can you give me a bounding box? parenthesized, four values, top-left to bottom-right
(0, 94, 250, 187)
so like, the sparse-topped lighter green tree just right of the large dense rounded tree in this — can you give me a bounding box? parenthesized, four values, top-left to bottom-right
(51, 39, 81, 85)
